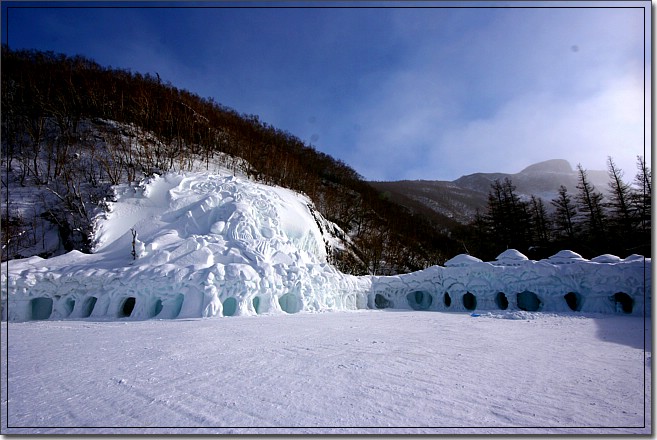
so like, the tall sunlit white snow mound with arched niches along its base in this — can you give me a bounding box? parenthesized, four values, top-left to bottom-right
(3, 172, 367, 320)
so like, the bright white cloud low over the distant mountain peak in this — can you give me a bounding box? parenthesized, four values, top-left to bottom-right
(411, 68, 643, 179)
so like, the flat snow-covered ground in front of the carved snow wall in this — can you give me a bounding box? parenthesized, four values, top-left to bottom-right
(2, 310, 651, 434)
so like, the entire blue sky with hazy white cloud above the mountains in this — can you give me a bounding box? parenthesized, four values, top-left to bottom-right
(2, 1, 651, 180)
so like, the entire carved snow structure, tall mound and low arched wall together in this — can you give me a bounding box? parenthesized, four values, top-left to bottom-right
(2, 171, 651, 321)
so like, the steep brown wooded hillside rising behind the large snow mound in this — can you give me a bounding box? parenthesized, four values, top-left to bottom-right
(2, 47, 456, 274)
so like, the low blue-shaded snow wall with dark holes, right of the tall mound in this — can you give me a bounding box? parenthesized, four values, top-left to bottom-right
(370, 249, 651, 315)
